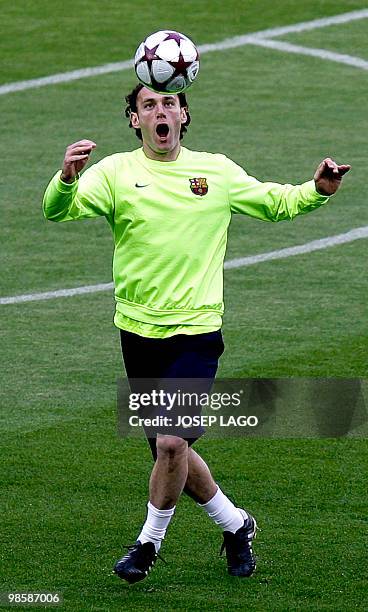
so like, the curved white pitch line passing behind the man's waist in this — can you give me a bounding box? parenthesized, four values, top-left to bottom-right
(0, 225, 368, 305)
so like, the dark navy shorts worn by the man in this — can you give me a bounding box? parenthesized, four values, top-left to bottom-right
(120, 330, 224, 459)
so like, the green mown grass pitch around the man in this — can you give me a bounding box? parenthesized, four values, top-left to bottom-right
(0, 0, 368, 612)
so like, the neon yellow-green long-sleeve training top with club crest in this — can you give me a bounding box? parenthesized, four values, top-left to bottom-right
(43, 147, 328, 338)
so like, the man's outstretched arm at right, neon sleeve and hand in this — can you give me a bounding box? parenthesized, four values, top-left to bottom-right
(229, 159, 350, 221)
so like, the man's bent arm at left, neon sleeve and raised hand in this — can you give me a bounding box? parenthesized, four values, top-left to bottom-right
(43, 140, 114, 221)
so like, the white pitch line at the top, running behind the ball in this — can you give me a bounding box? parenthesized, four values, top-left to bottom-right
(0, 9, 368, 96)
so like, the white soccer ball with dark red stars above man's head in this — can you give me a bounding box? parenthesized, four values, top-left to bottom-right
(134, 30, 199, 94)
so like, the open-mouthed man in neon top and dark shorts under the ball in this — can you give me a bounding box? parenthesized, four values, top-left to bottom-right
(44, 85, 350, 583)
